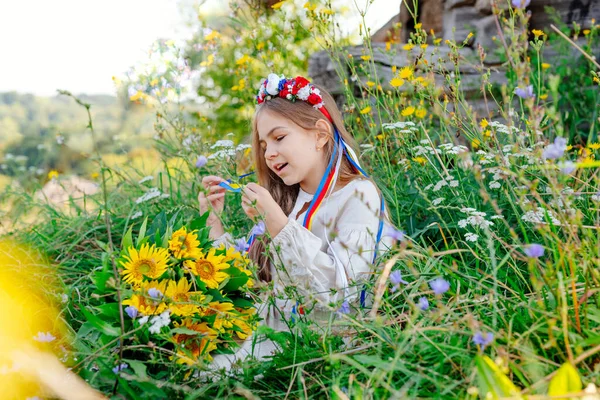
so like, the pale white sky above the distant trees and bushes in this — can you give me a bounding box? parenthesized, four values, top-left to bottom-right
(0, 0, 401, 96)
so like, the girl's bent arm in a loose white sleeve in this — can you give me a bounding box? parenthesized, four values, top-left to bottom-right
(271, 181, 380, 306)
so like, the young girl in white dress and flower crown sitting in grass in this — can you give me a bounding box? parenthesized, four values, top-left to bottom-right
(199, 74, 390, 364)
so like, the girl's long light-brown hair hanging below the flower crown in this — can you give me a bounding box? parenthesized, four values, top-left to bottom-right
(249, 85, 361, 282)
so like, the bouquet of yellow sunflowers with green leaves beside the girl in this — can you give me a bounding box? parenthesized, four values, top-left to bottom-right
(117, 214, 258, 365)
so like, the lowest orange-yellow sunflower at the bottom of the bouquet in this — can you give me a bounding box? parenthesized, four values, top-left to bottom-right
(173, 318, 217, 365)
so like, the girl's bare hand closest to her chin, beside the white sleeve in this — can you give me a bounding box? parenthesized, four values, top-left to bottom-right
(242, 183, 288, 237)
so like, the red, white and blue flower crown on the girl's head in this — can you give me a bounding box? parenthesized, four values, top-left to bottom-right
(256, 74, 333, 123)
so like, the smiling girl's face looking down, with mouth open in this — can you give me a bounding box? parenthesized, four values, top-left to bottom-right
(256, 110, 329, 193)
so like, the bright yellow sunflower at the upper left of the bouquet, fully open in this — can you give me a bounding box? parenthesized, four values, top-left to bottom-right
(121, 243, 169, 285)
